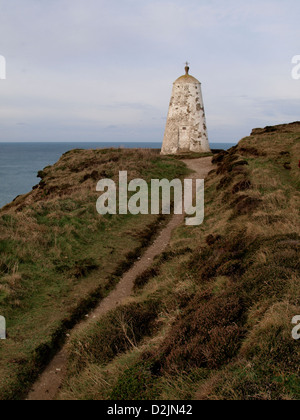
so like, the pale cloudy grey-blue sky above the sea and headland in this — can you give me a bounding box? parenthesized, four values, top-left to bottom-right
(0, 0, 300, 143)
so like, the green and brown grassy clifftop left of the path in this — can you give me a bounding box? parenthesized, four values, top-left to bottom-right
(0, 149, 186, 400)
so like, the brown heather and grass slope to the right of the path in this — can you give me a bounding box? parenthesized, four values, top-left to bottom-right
(59, 123, 300, 400)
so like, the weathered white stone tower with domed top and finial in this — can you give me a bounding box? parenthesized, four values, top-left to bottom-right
(161, 63, 211, 155)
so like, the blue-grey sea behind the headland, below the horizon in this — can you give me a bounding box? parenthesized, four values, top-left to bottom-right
(0, 143, 234, 208)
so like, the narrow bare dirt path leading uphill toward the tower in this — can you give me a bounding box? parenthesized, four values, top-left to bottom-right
(27, 157, 213, 401)
